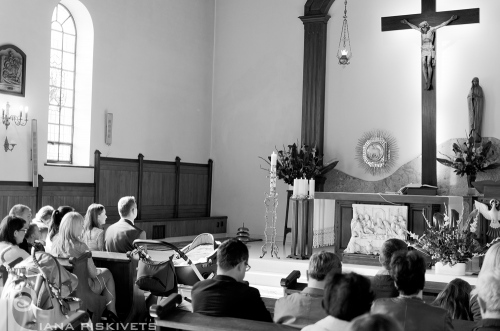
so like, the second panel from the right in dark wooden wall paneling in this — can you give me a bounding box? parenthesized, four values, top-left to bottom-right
(141, 161, 177, 220)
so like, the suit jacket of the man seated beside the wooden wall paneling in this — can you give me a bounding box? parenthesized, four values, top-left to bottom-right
(104, 218, 146, 253)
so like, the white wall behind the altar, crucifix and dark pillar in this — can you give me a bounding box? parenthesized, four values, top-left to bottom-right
(212, 0, 500, 237)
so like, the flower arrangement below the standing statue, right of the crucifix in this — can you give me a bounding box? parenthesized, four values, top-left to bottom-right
(436, 129, 500, 177)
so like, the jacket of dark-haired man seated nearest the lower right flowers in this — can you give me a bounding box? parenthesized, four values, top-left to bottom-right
(371, 296, 453, 331)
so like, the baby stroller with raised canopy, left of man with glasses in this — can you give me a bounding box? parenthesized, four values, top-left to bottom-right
(129, 233, 218, 297)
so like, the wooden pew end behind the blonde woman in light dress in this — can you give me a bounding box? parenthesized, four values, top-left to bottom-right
(57, 251, 106, 323)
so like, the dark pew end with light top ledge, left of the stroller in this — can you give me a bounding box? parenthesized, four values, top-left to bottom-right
(92, 251, 149, 323)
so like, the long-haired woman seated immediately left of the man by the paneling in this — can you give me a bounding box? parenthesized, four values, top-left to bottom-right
(82, 203, 107, 251)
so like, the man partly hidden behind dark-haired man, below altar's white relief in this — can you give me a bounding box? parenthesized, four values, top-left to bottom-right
(372, 238, 408, 299)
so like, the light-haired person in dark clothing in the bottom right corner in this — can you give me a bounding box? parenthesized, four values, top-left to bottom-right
(474, 272, 500, 331)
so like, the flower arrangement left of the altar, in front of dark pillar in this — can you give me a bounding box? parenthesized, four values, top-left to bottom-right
(259, 143, 338, 185)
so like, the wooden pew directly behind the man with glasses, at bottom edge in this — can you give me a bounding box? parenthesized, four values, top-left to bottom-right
(149, 294, 297, 331)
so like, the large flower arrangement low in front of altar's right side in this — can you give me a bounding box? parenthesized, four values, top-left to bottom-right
(408, 205, 500, 266)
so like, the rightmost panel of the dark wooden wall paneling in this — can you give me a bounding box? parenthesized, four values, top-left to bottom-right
(179, 163, 209, 217)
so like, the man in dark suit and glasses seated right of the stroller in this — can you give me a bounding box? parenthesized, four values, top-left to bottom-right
(191, 239, 273, 322)
